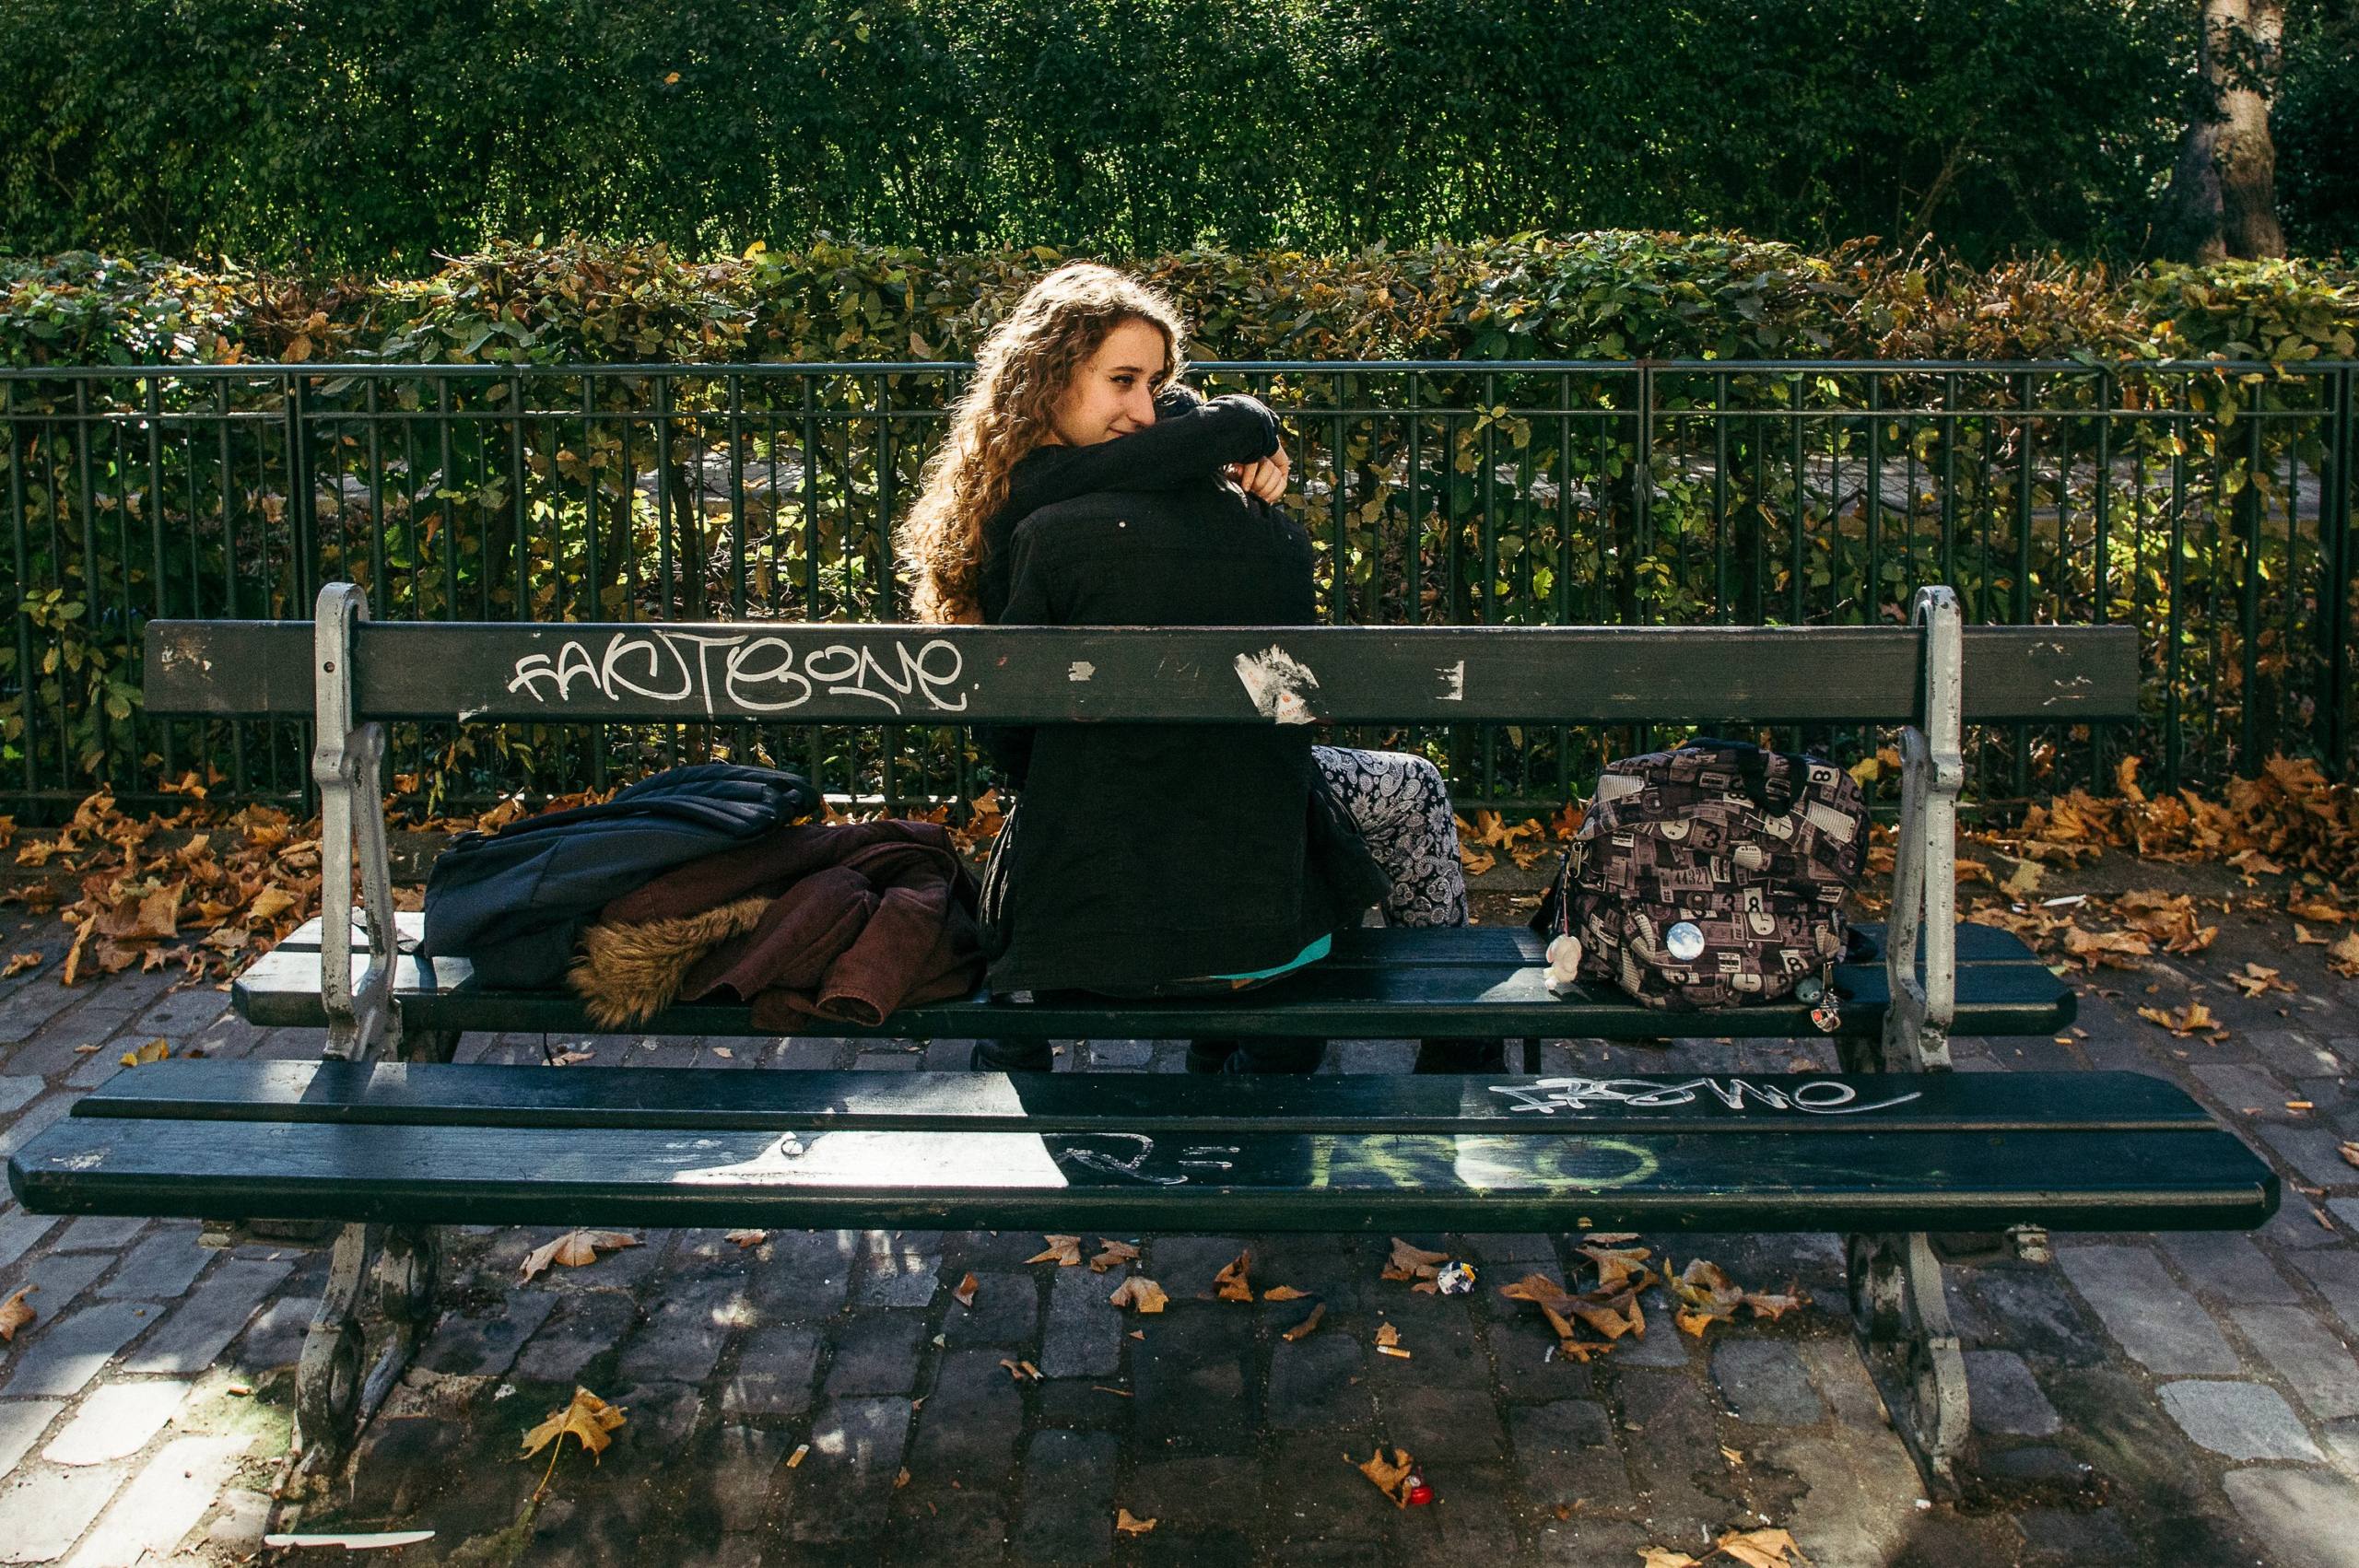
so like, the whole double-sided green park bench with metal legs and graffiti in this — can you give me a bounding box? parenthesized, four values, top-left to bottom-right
(9, 585, 2276, 1485)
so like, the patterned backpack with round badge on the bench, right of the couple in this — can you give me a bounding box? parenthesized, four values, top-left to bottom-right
(1531, 741, 1869, 1030)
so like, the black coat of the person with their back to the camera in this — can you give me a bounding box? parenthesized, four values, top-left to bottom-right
(984, 474, 1385, 993)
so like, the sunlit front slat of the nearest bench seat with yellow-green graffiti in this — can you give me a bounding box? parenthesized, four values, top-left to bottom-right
(9, 1116, 2276, 1235)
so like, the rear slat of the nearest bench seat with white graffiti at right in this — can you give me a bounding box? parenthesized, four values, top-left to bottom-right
(73, 1061, 2212, 1137)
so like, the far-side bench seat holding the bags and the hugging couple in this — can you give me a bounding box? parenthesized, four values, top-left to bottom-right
(233, 953, 2076, 1040)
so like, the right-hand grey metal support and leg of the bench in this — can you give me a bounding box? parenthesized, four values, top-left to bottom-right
(1842, 587, 1970, 1495)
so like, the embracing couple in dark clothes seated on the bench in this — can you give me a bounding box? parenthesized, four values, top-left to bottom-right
(901, 264, 1500, 1073)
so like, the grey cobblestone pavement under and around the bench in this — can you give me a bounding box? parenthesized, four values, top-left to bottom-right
(0, 859, 2359, 1568)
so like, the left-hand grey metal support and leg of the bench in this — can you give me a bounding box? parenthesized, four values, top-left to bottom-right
(295, 582, 448, 1474)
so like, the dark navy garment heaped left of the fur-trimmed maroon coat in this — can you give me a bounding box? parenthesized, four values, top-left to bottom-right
(417, 762, 818, 990)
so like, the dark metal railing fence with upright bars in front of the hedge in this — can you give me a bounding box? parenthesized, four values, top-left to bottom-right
(0, 361, 2359, 813)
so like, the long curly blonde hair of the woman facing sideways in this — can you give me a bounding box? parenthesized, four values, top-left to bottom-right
(898, 262, 1187, 620)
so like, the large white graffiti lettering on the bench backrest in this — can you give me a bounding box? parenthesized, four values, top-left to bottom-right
(507, 629, 968, 717)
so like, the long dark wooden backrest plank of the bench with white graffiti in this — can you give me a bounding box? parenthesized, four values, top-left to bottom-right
(144, 620, 2137, 724)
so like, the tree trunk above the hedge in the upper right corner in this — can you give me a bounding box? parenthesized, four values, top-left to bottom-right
(2154, 0, 2286, 262)
